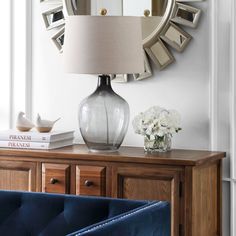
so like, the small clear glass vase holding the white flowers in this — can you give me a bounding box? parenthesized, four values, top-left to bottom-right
(144, 134, 171, 153)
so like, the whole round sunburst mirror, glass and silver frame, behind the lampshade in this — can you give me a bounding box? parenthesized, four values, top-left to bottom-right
(40, 0, 203, 82)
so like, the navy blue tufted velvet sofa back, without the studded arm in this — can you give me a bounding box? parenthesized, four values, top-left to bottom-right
(0, 191, 147, 236)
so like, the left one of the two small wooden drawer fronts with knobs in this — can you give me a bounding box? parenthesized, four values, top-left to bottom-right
(42, 163, 70, 194)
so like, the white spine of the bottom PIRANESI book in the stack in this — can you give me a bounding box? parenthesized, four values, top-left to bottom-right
(0, 141, 49, 149)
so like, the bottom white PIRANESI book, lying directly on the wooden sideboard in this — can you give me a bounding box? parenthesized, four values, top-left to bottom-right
(0, 139, 73, 150)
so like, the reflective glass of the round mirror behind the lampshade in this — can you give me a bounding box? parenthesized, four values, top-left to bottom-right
(67, 0, 168, 39)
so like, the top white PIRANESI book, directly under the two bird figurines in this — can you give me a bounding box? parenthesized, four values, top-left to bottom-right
(0, 129, 74, 143)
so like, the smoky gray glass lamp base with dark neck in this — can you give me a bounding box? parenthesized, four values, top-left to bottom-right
(79, 75, 129, 152)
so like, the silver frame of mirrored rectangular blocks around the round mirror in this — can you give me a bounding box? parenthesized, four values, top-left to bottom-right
(39, 0, 204, 82)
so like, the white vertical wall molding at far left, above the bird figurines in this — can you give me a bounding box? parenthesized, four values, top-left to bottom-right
(9, 0, 33, 128)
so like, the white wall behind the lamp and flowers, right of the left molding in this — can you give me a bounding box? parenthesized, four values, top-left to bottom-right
(32, 0, 236, 236)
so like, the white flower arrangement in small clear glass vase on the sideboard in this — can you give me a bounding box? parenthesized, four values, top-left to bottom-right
(132, 106, 181, 151)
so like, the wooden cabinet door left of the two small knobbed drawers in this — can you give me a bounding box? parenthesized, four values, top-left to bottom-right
(0, 161, 36, 191)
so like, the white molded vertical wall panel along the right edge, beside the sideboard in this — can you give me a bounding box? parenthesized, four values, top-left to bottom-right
(210, 0, 233, 236)
